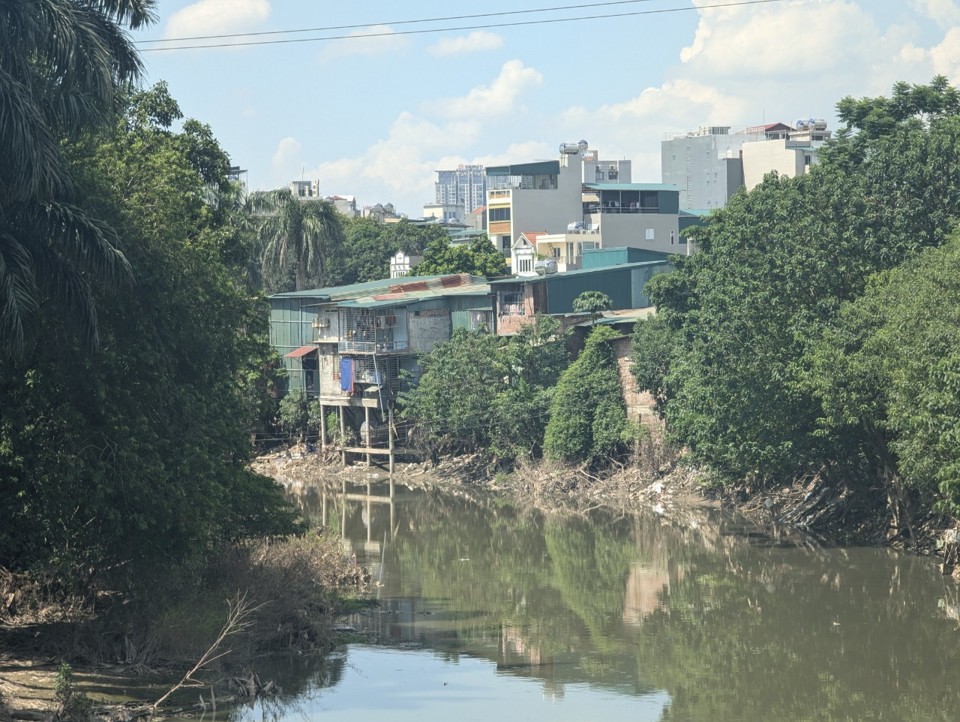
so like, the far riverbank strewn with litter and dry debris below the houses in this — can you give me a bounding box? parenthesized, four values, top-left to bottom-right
(256, 438, 960, 581)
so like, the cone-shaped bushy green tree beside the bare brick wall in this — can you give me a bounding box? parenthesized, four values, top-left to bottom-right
(544, 326, 630, 466)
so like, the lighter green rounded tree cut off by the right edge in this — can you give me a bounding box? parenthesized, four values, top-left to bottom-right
(809, 232, 960, 523)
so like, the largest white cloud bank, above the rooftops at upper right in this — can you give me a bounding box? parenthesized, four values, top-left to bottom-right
(544, 0, 940, 181)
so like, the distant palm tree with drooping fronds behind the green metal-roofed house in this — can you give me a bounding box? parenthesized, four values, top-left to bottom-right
(250, 188, 344, 291)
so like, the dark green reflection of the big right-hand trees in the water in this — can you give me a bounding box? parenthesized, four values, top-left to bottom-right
(638, 537, 960, 722)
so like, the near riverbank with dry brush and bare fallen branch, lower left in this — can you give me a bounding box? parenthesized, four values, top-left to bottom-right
(0, 532, 370, 722)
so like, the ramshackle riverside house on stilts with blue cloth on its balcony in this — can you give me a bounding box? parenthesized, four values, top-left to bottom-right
(269, 274, 494, 470)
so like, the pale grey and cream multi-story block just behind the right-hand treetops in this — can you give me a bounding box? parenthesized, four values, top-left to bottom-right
(660, 119, 830, 210)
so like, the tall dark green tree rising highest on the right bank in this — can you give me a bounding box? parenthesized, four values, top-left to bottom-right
(650, 79, 960, 484)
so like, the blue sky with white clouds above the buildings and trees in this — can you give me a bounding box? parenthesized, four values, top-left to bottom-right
(133, 0, 960, 217)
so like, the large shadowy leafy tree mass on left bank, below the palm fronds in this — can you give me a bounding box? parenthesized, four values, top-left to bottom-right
(0, 86, 296, 581)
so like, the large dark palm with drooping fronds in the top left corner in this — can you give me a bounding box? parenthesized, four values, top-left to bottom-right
(0, 0, 155, 355)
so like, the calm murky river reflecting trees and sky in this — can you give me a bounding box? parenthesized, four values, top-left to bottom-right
(219, 476, 960, 722)
